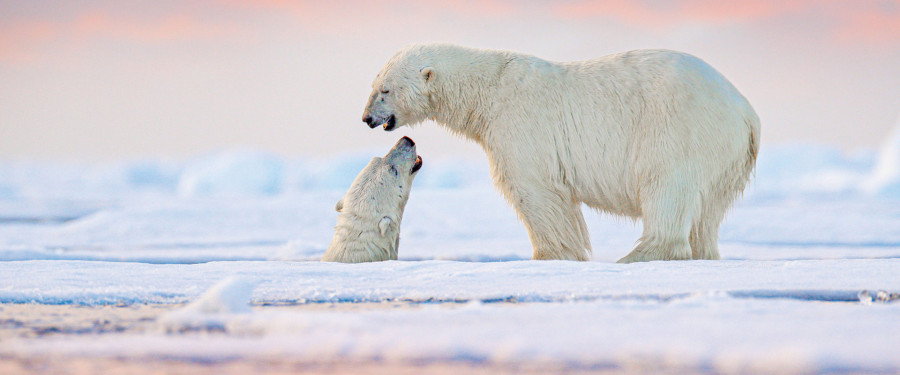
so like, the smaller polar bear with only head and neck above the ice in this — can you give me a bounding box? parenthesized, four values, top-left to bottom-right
(322, 137, 422, 263)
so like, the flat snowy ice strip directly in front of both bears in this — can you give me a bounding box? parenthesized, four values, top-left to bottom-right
(0, 257, 900, 306)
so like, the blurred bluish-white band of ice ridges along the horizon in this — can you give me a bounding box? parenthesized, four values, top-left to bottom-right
(7, 142, 900, 203)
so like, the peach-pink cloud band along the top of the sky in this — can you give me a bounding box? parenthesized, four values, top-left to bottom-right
(0, 0, 900, 62)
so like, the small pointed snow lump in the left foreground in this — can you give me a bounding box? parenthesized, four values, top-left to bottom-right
(158, 277, 256, 332)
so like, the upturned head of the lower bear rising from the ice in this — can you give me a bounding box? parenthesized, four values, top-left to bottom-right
(334, 137, 422, 236)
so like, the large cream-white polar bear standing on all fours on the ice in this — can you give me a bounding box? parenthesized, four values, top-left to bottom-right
(363, 44, 760, 263)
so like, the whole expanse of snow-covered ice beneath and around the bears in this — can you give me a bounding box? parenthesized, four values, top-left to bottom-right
(0, 135, 900, 373)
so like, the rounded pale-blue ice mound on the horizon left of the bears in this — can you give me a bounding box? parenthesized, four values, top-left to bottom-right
(178, 151, 284, 197)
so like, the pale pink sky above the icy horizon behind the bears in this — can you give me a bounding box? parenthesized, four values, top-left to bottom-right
(0, 0, 900, 159)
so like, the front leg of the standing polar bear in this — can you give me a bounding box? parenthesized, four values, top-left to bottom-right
(506, 183, 591, 261)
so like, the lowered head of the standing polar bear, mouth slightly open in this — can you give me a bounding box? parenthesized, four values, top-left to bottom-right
(363, 46, 434, 131)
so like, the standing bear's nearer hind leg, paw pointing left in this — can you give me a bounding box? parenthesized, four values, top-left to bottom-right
(618, 184, 700, 263)
